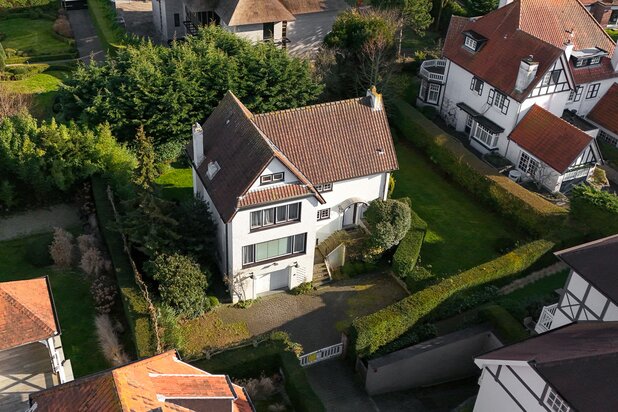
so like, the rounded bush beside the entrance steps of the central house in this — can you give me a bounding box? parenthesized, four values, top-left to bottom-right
(365, 199, 411, 261)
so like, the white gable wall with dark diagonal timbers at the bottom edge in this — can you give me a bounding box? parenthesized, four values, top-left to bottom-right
(474, 360, 547, 412)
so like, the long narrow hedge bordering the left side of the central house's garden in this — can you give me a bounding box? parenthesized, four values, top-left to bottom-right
(92, 176, 155, 358)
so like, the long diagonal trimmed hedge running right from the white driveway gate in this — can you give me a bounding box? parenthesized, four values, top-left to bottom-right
(350, 240, 553, 357)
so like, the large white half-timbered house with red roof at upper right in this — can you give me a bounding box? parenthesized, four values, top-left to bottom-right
(417, 0, 618, 192)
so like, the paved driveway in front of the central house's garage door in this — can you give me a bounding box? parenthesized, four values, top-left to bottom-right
(218, 274, 406, 353)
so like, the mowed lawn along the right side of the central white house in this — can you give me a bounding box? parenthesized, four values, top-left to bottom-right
(393, 143, 522, 275)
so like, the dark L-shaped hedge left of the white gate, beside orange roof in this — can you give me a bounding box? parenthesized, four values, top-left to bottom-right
(192, 332, 326, 412)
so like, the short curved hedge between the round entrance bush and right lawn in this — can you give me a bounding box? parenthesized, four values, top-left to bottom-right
(393, 198, 427, 278)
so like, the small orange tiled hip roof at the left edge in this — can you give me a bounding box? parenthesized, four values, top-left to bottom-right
(0, 277, 60, 350)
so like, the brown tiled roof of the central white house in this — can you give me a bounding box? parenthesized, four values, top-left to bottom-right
(187, 92, 398, 222)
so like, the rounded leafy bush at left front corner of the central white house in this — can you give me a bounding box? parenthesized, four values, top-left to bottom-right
(146, 254, 209, 317)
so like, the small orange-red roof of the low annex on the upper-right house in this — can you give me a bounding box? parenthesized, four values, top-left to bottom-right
(510, 105, 592, 174)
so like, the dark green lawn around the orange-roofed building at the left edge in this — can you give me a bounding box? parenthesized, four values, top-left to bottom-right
(0, 234, 109, 377)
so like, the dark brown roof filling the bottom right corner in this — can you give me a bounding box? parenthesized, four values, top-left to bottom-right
(477, 322, 618, 411)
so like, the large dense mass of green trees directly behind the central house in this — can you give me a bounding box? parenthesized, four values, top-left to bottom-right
(59, 27, 322, 161)
